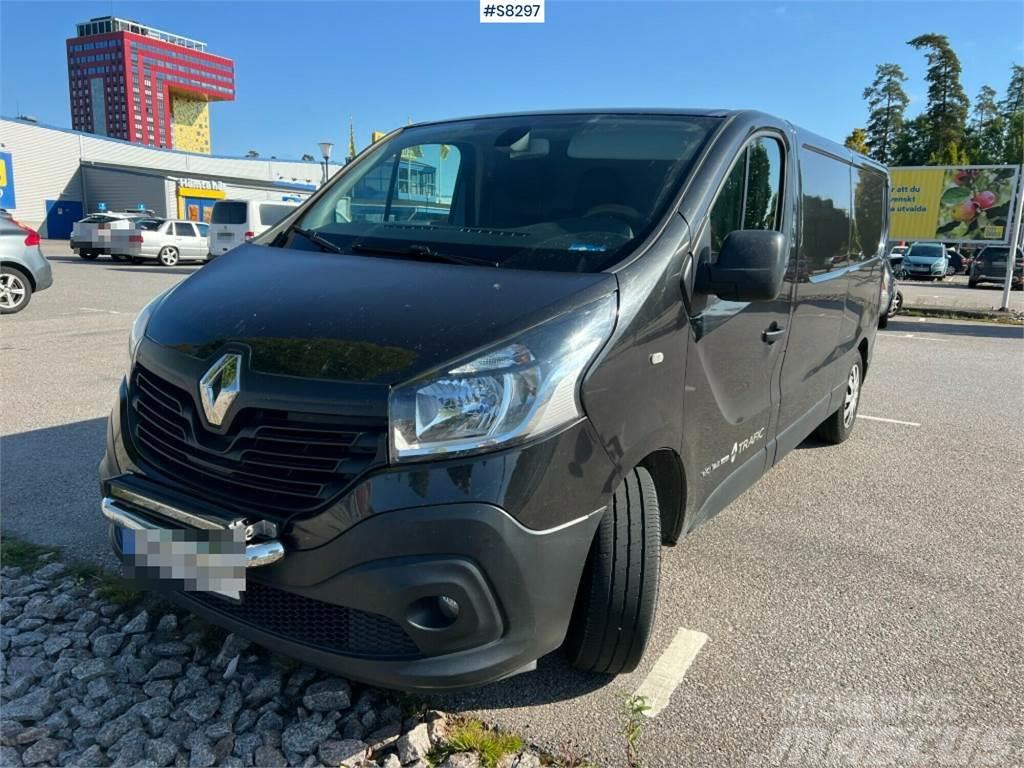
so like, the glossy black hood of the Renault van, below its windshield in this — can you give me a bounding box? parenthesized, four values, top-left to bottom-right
(145, 245, 616, 385)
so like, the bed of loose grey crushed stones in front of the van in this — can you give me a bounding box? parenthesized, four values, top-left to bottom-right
(0, 559, 540, 768)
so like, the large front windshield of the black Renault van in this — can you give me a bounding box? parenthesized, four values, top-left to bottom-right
(288, 114, 719, 271)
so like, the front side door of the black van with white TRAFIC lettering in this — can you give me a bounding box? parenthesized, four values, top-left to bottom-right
(683, 133, 794, 523)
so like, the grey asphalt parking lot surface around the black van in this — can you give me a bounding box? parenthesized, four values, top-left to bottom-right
(6, 244, 1024, 767)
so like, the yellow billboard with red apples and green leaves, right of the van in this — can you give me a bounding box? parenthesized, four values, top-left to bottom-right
(889, 165, 1020, 243)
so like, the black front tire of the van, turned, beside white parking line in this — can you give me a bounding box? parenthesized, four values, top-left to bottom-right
(564, 467, 662, 675)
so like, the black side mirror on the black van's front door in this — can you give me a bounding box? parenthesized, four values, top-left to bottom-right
(695, 229, 788, 301)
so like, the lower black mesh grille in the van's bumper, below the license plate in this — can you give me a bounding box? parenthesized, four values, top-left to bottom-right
(188, 581, 421, 658)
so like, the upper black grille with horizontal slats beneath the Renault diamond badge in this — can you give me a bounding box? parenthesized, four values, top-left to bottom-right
(128, 366, 383, 516)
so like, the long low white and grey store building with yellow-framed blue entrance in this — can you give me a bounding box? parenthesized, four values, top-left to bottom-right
(0, 118, 341, 240)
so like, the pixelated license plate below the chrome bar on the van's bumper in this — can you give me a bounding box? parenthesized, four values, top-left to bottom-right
(118, 527, 246, 600)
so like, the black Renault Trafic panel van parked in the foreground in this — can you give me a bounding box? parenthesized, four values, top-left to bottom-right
(100, 111, 888, 689)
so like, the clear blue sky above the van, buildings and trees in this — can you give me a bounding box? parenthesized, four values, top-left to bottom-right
(0, 0, 1024, 158)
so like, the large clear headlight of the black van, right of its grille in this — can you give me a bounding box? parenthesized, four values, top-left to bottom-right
(388, 295, 615, 461)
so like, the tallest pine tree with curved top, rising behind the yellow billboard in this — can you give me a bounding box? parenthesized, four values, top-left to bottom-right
(907, 34, 970, 159)
